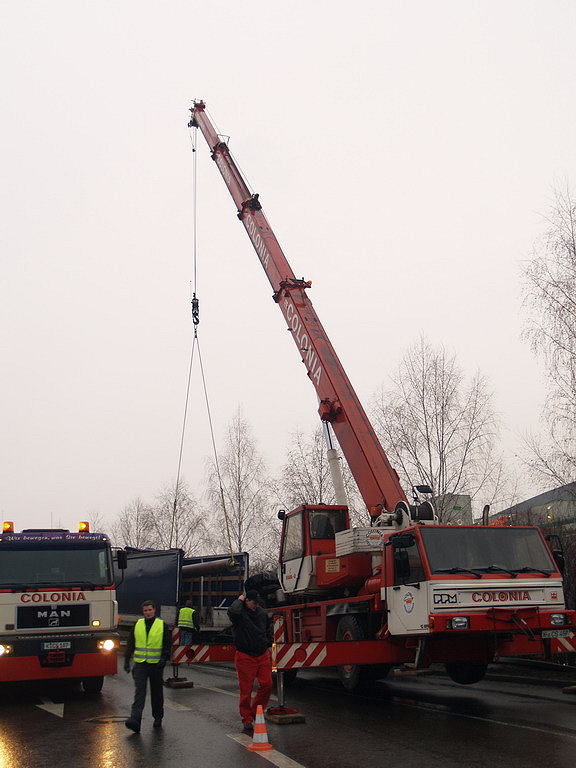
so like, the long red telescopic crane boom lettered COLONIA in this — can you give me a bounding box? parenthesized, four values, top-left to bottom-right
(190, 101, 407, 517)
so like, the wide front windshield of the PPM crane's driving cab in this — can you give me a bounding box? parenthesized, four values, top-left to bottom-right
(420, 526, 558, 575)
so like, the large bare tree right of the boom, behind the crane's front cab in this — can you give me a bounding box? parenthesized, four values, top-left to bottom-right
(373, 338, 505, 522)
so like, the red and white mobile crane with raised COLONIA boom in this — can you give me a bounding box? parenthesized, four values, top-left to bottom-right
(187, 101, 576, 690)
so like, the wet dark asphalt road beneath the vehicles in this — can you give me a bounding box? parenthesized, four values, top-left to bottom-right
(0, 666, 576, 768)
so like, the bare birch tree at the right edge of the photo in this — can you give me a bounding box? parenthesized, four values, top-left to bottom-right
(523, 188, 576, 485)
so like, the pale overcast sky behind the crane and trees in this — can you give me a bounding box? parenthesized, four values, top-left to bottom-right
(0, 0, 576, 529)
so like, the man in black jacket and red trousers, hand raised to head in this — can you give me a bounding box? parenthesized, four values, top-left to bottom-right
(228, 589, 273, 734)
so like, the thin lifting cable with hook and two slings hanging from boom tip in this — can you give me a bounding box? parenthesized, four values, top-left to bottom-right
(169, 121, 234, 565)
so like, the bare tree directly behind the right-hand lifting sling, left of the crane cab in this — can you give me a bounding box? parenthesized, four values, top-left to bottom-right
(206, 408, 272, 558)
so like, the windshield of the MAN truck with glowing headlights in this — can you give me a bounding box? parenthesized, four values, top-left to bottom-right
(0, 545, 112, 588)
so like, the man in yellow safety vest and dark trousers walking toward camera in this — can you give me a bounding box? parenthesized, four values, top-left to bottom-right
(124, 600, 171, 733)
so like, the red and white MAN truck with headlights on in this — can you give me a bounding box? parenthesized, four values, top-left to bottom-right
(0, 522, 124, 693)
